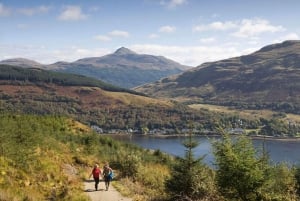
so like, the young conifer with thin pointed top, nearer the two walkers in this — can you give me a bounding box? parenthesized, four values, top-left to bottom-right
(166, 123, 217, 201)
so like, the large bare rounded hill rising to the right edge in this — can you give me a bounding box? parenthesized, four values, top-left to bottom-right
(135, 41, 300, 113)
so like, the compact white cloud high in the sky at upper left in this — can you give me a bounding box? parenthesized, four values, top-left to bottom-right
(58, 6, 87, 21)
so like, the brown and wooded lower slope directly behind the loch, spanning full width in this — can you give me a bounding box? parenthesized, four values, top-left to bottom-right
(0, 66, 300, 137)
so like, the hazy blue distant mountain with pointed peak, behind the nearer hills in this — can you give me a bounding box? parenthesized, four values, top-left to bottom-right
(0, 47, 190, 88)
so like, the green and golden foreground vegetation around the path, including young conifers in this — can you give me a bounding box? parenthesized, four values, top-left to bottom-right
(0, 114, 300, 201)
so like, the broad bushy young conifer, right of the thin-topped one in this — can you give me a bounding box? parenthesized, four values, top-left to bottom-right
(213, 134, 265, 201)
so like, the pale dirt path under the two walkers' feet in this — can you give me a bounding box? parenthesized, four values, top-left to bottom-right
(84, 179, 132, 201)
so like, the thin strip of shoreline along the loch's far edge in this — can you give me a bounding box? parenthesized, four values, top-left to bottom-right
(101, 133, 300, 141)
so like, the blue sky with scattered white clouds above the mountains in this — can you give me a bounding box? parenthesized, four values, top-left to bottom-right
(0, 0, 300, 66)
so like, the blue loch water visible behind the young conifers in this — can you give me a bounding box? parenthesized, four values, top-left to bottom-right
(113, 135, 300, 166)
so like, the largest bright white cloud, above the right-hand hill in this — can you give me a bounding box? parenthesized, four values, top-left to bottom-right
(233, 18, 285, 38)
